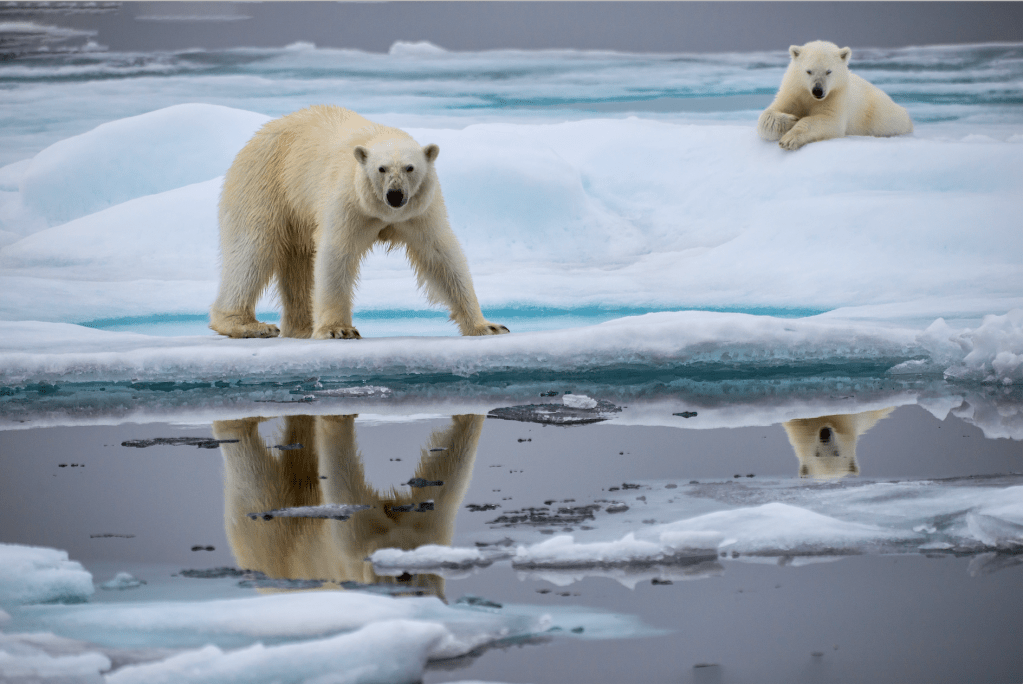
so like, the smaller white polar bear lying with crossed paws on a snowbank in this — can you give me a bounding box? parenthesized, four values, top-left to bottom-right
(757, 41, 913, 149)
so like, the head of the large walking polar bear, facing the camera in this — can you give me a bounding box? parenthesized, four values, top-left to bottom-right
(352, 135, 440, 218)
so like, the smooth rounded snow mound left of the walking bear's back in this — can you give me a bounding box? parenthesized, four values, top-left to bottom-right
(20, 104, 269, 223)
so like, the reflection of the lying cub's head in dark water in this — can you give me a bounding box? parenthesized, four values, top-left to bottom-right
(785, 408, 894, 480)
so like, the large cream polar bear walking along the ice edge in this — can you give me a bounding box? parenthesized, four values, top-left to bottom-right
(210, 105, 508, 339)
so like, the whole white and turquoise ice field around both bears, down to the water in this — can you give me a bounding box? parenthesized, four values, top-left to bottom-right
(0, 44, 1023, 394)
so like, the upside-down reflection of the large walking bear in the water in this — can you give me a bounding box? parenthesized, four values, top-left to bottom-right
(213, 415, 484, 595)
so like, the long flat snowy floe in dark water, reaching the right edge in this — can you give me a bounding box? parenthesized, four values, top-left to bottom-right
(358, 478, 1023, 588)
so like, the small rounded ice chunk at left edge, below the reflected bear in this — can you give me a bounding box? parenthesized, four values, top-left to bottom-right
(0, 544, 95, 605)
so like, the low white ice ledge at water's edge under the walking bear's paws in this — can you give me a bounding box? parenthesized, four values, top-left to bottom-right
(0, 310, 1023, 386)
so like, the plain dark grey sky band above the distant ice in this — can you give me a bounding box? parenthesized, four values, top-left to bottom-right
(7, 1, 1023, 52)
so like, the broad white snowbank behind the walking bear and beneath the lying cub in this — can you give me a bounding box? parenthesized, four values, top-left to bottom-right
(0, 111, 1023, 322)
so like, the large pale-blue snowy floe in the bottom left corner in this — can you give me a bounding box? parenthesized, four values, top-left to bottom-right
(0, 550, 655, 684)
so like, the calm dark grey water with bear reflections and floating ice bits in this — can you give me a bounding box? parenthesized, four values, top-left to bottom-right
(0, 406, 1023, 682)
